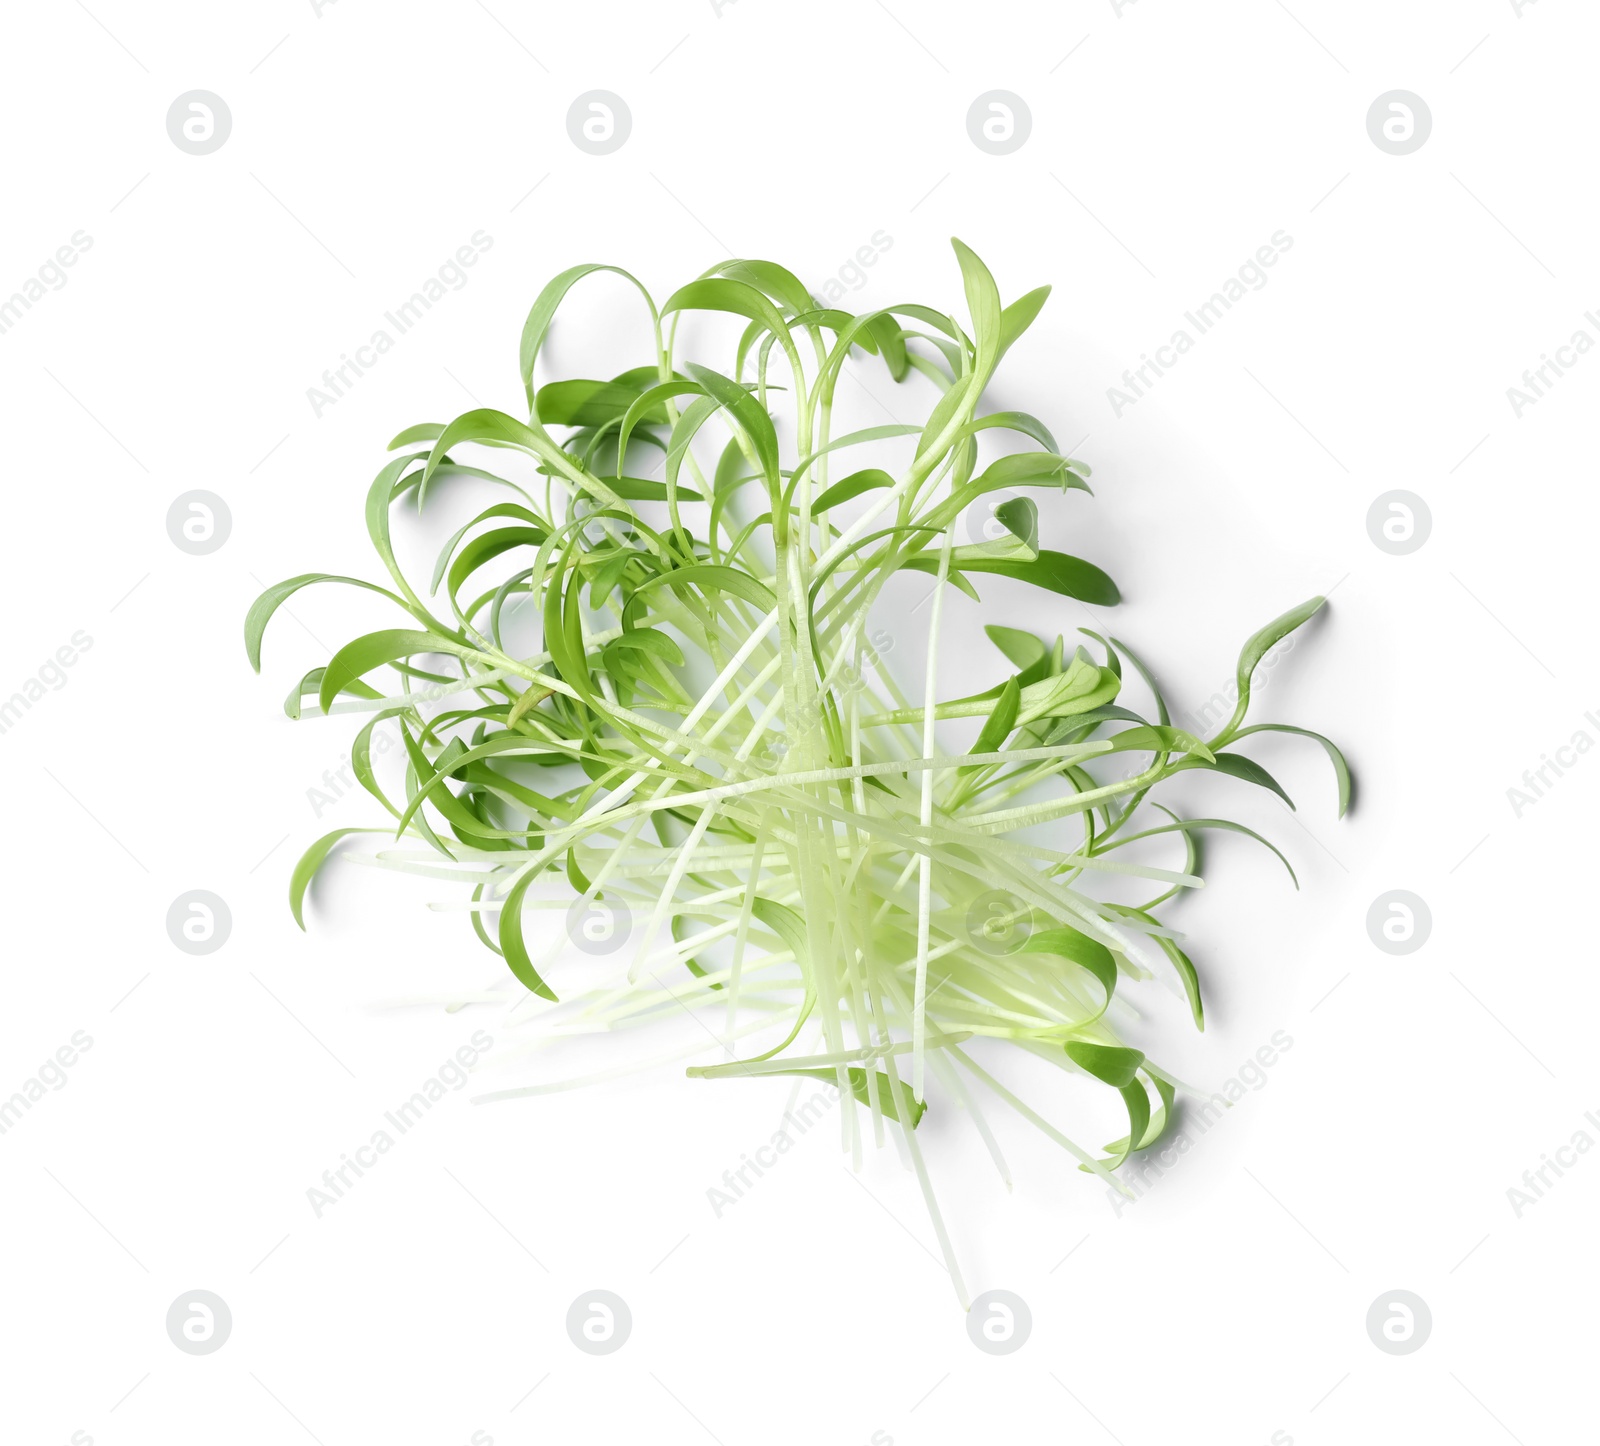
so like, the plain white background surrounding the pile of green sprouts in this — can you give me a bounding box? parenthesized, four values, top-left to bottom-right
(0, 0, 1600, 1446)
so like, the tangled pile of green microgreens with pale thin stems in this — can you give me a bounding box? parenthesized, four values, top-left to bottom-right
(245, 242, 1349, 1302)
